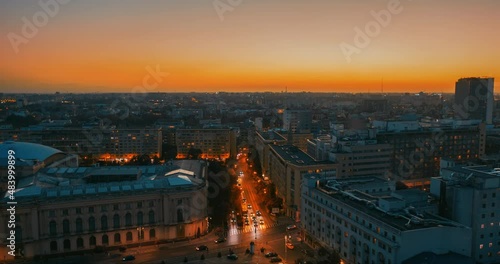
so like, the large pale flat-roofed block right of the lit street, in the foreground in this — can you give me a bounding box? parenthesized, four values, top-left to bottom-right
(301, 175, 471, 264)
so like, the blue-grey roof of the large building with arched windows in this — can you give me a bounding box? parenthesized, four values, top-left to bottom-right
(4, 160, 205, 202)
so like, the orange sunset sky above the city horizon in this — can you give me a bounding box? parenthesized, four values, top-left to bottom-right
(0, 0, 500, 93)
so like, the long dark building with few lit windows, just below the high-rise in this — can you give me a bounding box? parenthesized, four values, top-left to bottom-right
(376, 121, 486, 180)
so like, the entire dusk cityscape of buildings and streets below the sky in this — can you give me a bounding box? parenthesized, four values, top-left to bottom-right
(0, 77, 500, 264)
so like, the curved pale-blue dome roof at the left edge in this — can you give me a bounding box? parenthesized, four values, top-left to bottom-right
(0, 141, 63, 163)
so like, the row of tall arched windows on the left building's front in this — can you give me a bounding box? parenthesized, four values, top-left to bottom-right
(49, 210, 155, 236)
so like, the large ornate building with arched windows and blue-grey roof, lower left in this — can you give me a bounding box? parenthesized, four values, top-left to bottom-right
(0, 141, 208, 259)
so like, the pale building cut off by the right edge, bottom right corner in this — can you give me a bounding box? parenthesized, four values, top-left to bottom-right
(431, 166, 500, 263)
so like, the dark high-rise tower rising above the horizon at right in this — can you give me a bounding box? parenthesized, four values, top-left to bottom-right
(453, 77, 494, 124)
